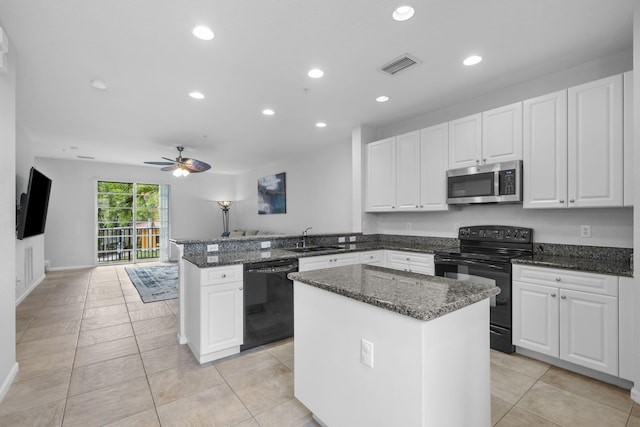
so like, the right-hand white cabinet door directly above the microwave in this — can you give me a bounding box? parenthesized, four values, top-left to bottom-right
(482, 102, 522, 163)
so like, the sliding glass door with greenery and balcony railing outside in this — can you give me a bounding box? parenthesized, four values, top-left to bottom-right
(96, 181, 169, 264)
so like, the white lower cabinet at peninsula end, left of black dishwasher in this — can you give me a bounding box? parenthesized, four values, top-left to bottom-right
(185, 263, 244, 363)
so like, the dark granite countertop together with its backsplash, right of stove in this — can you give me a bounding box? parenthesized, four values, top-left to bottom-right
(511, 243, 633, 277)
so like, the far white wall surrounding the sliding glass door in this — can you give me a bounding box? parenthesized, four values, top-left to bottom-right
(36, 158, 234, 269)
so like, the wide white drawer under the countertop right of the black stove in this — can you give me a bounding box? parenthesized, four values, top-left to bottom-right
(513, 261, 618, 296)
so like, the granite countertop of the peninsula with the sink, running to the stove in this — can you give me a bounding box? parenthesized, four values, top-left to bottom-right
(183, 242, 450, 268)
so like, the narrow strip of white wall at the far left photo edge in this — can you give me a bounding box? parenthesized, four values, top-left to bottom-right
(0, 24, 18, 401)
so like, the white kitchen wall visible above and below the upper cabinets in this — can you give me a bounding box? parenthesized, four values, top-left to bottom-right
(363, 47, 633, 248)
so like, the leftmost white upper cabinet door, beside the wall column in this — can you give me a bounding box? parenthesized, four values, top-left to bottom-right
(366, 137, 396, 211)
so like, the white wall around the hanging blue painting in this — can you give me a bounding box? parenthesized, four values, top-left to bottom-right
(230, 140, 352, 234)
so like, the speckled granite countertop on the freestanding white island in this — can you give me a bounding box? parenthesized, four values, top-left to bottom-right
(288, 264, 500, 320)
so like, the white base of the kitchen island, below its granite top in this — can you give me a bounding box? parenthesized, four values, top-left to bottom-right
(294, 281, 491, 427)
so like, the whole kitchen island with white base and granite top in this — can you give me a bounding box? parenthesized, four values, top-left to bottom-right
(289, 264, 499, 426)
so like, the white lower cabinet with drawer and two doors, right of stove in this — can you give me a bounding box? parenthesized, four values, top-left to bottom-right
(513, 265, 619, 376)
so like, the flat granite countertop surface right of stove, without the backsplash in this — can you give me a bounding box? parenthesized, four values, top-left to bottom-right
(511, 254, 633, 277)
